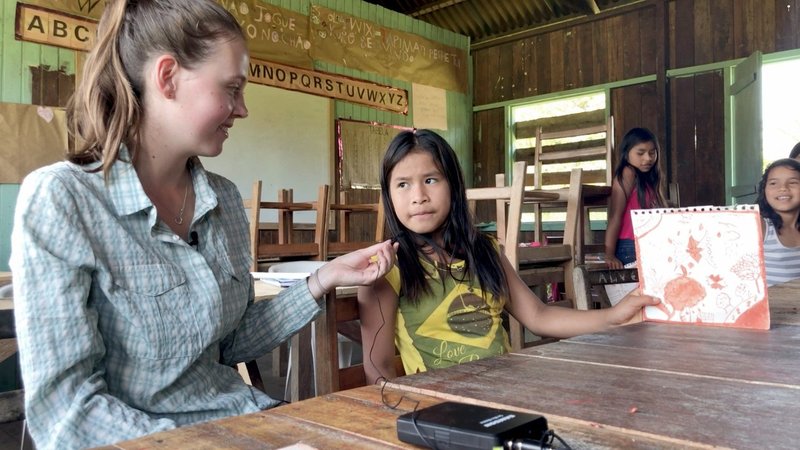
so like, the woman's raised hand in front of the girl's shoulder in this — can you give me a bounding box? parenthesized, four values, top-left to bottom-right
(309, 240, 398, 298)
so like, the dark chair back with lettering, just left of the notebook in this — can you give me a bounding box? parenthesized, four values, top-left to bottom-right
(572, 264, 639, 310)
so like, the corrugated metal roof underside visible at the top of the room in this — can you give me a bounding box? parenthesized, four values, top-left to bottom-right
(366, 0, 642, 45)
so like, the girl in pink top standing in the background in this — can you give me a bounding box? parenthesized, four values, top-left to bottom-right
(605, 128, 667, 269)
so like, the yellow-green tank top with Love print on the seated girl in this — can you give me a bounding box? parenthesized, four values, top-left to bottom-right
(386, 253, 510, 374)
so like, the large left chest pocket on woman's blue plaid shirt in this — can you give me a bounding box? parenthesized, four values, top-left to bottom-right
(107, 264, 205, 359)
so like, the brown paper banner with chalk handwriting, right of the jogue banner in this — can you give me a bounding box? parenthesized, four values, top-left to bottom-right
(309, 5, 467, 92)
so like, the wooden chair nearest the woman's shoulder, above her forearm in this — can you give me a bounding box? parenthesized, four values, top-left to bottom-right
(244, 180, 329, 272)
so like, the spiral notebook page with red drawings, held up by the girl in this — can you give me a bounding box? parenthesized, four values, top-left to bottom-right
(631, 205, 769, 330)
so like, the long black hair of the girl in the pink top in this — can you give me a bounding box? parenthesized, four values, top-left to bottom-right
(614, 128, 667, 209)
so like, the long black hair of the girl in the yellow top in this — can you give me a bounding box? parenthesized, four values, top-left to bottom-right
(381, 130, 508, 304)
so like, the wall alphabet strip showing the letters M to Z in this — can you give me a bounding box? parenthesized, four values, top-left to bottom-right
(248, 59, 408, 114)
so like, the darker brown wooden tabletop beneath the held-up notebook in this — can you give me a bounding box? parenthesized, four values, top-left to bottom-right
(393, 281, 800, 449)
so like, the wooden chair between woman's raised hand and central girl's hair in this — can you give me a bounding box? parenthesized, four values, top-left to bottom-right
(326, 192, 385, 258)
